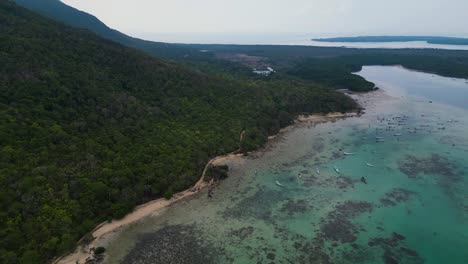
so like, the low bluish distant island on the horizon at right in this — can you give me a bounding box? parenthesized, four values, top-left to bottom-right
(312, 36, 468, 45)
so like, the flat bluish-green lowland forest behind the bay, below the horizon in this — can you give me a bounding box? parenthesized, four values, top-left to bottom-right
(190, 44, 468, 91)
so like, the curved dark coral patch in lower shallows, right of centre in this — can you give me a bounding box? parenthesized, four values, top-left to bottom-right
(320, 201, 373, 243)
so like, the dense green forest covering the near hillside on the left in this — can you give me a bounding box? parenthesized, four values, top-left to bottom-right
(0, 1, 357, 263)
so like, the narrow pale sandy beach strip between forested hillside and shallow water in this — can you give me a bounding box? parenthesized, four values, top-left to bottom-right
(53, 108, 358, 264)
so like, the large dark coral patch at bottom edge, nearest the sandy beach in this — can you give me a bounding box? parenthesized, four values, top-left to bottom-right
(122, 225, 222, 264)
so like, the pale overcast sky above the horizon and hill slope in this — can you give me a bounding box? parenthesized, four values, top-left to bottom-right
(63, 0, 468, 41)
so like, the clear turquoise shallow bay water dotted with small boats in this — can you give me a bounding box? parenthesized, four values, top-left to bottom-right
(105, 67, 468, 264)
